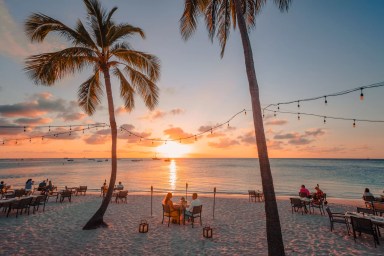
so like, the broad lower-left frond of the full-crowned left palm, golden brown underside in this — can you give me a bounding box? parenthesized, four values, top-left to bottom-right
(24, 47, 97, 85)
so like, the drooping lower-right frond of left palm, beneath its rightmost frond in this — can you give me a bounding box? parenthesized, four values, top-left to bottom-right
(124, 66, 159, 110)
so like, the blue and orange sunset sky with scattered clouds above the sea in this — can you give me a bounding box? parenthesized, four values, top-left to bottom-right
(0, 0, 384, 159)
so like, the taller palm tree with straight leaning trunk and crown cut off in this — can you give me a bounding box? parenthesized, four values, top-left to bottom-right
(180, 0, 291, 255)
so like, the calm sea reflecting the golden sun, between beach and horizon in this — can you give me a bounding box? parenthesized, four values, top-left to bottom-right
(0, 159, 384, 199)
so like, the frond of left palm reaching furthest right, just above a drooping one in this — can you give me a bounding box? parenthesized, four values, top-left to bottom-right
(110, 48, 160, 82)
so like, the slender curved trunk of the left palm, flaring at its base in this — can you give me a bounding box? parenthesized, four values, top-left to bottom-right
(83, 67, 117, 230)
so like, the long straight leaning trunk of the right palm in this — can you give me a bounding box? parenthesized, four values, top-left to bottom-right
(234, 0, 285, 256)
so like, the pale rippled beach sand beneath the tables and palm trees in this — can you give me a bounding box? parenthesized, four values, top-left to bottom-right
(0, 195, 384, 255)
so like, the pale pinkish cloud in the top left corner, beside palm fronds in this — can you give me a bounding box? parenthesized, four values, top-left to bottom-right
(0, 1, 64, 61)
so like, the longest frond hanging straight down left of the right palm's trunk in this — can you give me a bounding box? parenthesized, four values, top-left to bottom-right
(216, 0, 231, 58)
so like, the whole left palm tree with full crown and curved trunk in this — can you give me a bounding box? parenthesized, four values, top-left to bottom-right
(25, 0, 160, 229)
